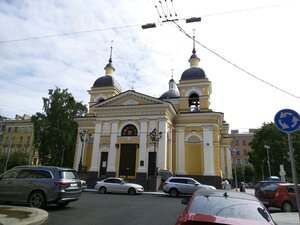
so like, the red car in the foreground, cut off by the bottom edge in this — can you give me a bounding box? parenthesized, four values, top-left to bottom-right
(176, 189, 276, 225)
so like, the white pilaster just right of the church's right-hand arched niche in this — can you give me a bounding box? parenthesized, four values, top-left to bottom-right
(203, 127, 215, 176)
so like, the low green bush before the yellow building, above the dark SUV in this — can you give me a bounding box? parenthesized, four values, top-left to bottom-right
(0, 151, 29, 173)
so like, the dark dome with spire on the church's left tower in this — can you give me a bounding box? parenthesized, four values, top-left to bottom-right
(93, 41, 122, 91)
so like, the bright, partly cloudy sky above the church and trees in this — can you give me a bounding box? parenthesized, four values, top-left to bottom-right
(0, 0, 300, 130)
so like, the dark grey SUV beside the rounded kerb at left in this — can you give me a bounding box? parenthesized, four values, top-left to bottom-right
(0, 166, 81, 208)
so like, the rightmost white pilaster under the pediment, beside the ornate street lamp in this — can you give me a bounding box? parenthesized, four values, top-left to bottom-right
(157, 119, 168, 171)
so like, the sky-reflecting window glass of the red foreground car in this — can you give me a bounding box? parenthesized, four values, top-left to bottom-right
(189, 196, 270, 221)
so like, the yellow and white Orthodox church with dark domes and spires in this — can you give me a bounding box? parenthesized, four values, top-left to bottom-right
(74, 39, 232, 189)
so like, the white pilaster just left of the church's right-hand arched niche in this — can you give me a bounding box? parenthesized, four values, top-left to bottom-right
(176, 127, 185, 175)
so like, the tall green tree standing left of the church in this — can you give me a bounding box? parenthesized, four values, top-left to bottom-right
(32, 88, 87, 167)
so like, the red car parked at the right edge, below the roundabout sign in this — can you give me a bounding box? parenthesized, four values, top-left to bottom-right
(255, 182, 300, 212)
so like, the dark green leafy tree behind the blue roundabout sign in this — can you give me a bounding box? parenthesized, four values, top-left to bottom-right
(249, 123, 300, 181)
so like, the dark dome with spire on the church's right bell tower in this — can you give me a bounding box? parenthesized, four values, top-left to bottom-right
(180, 31, 206, 80)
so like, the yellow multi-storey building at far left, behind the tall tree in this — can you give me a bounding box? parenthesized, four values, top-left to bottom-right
(0, 115, 38, 167)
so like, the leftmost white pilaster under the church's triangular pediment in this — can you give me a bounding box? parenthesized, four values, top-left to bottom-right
(89, 122, 102, 172)
